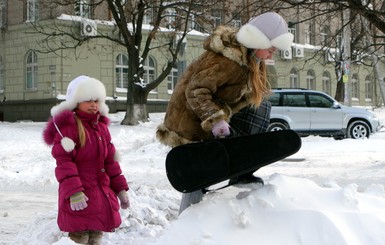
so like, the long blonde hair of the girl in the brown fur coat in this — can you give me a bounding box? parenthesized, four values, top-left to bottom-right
(248, 52, 270, 106)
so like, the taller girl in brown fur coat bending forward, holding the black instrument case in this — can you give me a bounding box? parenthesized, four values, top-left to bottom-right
(156, 12, 293, 212)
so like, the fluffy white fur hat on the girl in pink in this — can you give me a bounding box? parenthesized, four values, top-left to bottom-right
(51, 75, 109, 116)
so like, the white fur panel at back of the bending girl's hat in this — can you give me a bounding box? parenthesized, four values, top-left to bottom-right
(237, 24, 271, 49)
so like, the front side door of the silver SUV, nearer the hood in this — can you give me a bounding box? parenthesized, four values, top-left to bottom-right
(308, 93, 343, 130)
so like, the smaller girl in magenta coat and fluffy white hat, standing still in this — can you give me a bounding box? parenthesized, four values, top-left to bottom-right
(43, 76, 130, 244)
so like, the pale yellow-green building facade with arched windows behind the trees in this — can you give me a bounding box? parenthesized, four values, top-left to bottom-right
(0, 0, 381, 122)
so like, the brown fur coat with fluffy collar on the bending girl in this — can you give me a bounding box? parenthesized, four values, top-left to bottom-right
(156, 26, 251, 147)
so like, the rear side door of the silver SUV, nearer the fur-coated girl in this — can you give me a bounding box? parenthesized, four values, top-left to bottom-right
(282, 92, 310, 131)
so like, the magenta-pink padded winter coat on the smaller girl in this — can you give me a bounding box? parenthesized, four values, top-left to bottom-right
(43, 110, 128, 232)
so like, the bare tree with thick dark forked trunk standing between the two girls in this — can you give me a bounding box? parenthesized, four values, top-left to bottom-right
(30, 0, 231, 125)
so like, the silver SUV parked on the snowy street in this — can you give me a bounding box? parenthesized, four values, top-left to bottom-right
(268, 89, 381, 139)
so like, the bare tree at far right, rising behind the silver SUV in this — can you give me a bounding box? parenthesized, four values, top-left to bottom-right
(280, 0, 385, 104)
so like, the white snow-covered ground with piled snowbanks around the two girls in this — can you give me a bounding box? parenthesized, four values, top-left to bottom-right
(0, 109, 385, 245)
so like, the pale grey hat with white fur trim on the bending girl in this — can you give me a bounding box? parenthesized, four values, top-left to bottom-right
(237, 12, 294, 49)
